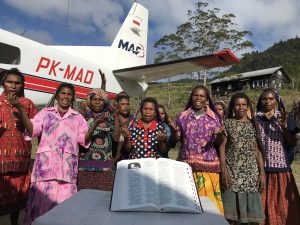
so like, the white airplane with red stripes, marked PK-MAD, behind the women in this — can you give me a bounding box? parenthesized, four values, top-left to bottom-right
(0, 2, 239, 104)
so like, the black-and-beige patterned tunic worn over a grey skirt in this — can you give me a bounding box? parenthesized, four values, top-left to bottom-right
(225, 119, 259, 192)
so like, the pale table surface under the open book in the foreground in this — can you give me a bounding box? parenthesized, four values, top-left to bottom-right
(33, 189, 228, 225)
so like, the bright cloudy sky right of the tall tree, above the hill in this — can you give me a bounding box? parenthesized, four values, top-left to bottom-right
(210, 0, 300, 51)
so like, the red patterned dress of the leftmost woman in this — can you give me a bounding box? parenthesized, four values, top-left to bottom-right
(0, 93, 37, 216)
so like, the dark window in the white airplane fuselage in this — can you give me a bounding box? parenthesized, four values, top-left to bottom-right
(0, 42, 21, 65)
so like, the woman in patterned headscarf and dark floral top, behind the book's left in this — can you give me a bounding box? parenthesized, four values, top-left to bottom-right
(78, 89, 114, 191)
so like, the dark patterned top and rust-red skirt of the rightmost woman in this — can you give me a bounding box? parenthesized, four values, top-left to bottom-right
(256, 111, 300, 225)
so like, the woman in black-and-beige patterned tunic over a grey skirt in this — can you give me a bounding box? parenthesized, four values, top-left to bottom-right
(220, 92, 265, 225)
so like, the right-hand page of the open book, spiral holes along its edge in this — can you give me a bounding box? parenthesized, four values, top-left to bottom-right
(156, 158, 203, 213)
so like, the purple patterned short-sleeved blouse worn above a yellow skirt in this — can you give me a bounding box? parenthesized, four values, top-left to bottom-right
(176, 107, 221, 173)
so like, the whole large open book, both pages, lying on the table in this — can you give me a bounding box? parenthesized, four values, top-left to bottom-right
(110, 158, 203, 213)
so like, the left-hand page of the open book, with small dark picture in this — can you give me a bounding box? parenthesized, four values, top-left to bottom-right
(111, 159, 158, 211)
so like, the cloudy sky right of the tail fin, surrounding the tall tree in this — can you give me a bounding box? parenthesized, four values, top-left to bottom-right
(142, 0, 300, 57)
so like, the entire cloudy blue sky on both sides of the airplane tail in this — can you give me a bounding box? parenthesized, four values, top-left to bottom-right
(0, 0, 300, 63)
